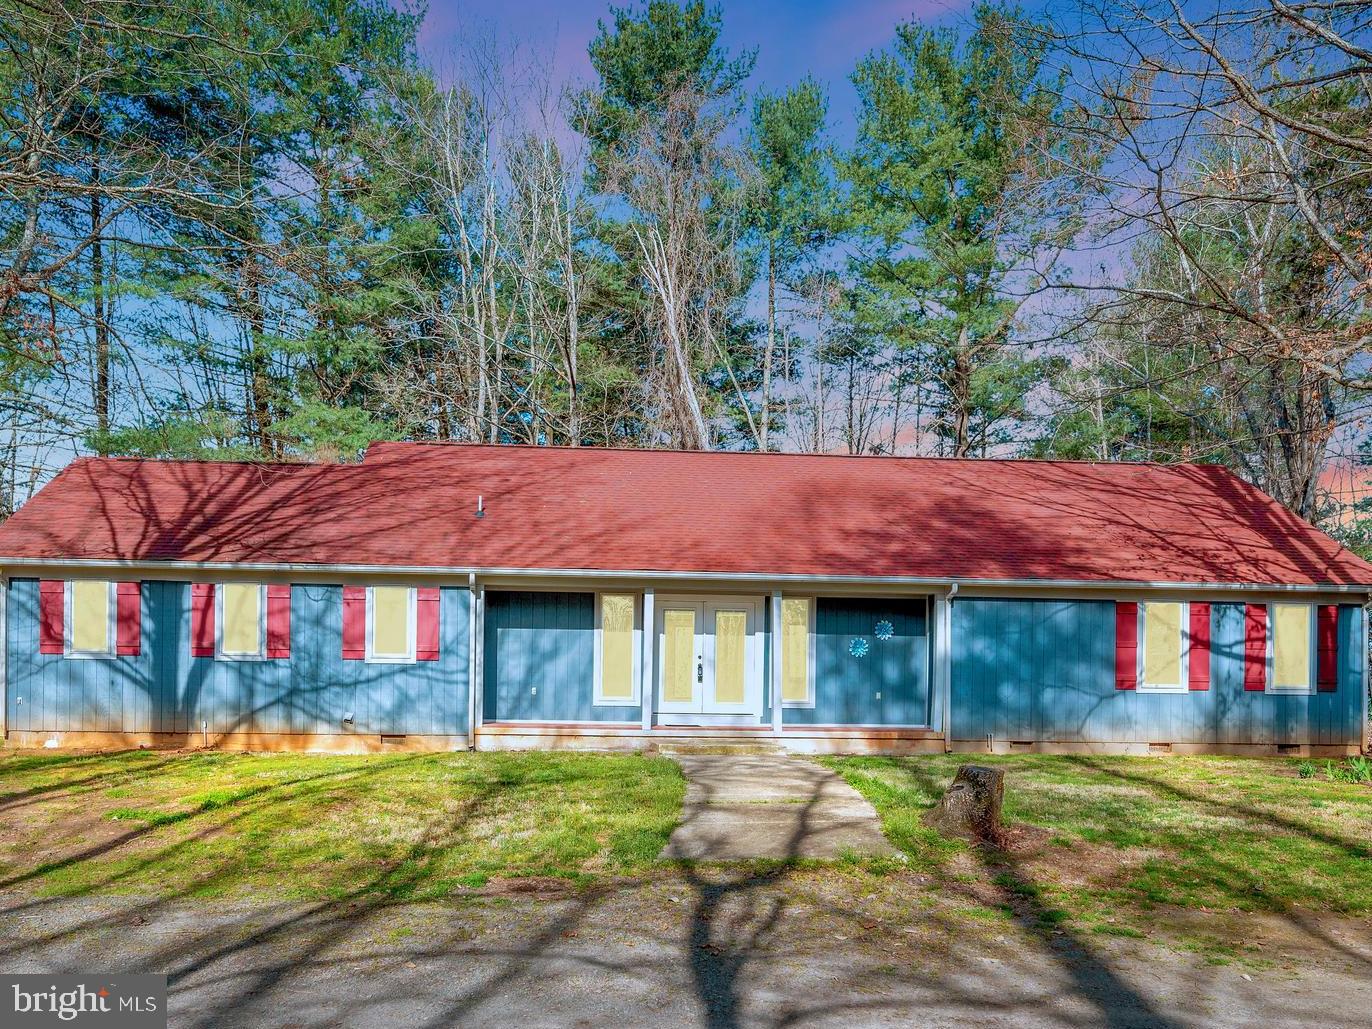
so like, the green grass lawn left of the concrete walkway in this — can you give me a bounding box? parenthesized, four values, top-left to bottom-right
(0, 750, 685, 899)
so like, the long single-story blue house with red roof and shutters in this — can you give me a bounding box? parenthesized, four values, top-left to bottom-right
(0, 443, 1372, 755)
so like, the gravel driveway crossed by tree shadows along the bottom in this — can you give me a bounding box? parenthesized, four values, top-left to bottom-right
(0, 867, 1372, 1029)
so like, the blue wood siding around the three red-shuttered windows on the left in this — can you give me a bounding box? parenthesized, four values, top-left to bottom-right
(5, 579, 469, 735)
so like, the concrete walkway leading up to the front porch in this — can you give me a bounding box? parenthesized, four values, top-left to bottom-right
(661, 755, 895, 862)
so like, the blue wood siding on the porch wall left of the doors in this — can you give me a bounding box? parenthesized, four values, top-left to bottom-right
(483, 590, 642, 722)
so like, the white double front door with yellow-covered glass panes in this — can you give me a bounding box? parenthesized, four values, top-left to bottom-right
(656, 597, 761, 715)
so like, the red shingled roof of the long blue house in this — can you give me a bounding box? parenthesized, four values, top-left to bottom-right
(0, 443, 1372, 586)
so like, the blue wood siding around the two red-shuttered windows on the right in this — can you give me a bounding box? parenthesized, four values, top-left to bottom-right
(952, 598, 1365, 745)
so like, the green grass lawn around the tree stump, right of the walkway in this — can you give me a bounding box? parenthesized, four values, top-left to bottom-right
(826, 755, 1372, 925)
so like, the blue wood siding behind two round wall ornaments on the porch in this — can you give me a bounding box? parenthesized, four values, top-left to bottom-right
(782, 597, 929, 726)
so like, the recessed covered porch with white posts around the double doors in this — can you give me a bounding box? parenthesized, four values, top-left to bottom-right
(471, 579, 948, 753)
